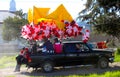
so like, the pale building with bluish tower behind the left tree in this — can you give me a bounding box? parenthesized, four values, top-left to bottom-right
(0, 0, 17, 53)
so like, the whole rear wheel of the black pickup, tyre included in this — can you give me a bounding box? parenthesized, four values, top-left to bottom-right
(41, 61, 54, 72)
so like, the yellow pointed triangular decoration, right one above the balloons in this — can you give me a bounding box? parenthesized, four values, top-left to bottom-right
(46, 4, 73, 30)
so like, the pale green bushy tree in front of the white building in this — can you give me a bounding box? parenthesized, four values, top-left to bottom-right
(2, 10, 28, 41)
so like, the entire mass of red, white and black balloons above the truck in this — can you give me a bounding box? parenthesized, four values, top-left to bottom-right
(21, 20, 89, 42)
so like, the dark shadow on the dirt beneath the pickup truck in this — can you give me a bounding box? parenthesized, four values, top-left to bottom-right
(20, 66, 120, 76)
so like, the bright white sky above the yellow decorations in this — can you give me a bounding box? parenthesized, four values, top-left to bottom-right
(0, 0, 86, 19)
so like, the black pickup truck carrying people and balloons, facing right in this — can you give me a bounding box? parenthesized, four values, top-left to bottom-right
(27, 41, 114, 72)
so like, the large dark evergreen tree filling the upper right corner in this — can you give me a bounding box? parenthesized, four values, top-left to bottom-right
(78, 0, 120, 39)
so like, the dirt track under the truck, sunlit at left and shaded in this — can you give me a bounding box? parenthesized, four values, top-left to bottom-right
(0, 62, 120, 77)
